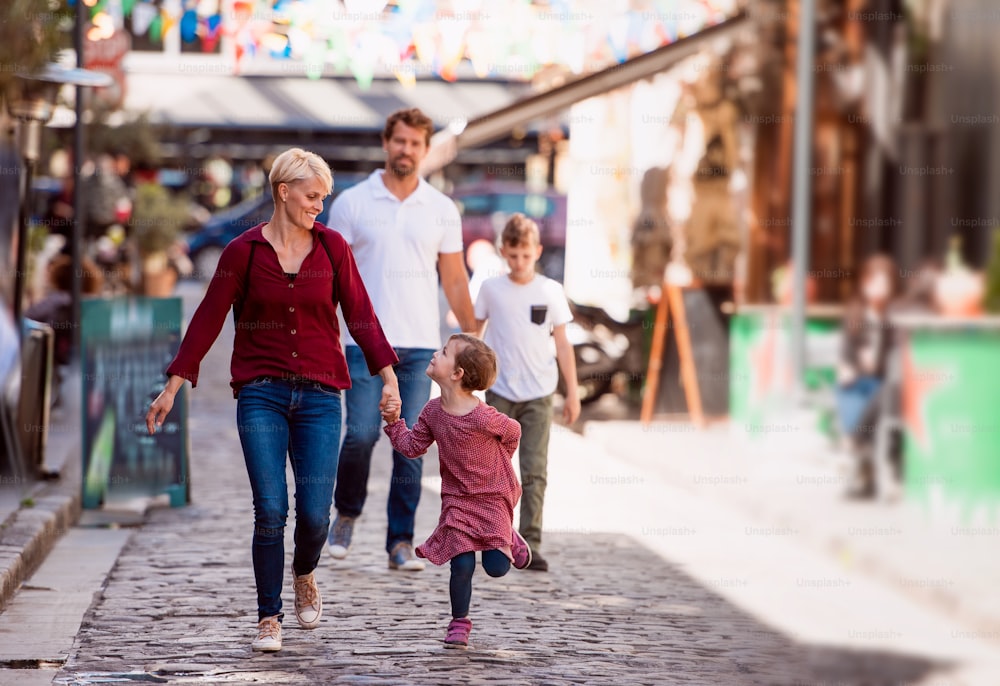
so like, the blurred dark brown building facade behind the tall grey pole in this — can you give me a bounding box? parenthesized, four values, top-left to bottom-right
(746, 0, 1000, 302)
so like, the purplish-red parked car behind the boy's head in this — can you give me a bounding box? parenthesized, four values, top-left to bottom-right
(451, 181, 566, 282)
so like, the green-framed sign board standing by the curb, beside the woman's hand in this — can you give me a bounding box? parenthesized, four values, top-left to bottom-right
(80, 297, 189, 508)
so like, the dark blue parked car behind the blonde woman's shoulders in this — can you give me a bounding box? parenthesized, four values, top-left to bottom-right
(187, 174, 365, 281)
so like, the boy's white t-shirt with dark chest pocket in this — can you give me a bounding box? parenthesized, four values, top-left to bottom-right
(476, 274, 573, 402)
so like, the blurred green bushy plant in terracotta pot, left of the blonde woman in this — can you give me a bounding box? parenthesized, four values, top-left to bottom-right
(129, 183, 190, 297)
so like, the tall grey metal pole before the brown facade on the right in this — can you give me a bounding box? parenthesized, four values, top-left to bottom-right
(791, 0, 816, 402)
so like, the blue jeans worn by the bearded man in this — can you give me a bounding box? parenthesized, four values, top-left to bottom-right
(334, 345, 434, 552)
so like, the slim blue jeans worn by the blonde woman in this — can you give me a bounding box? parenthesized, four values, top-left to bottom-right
(236, 380, 341, 619)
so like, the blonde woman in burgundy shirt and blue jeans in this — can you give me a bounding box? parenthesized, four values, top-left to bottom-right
(146, 148, 399, 651)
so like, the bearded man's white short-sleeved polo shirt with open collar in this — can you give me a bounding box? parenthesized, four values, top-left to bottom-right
(326, 169, 462, 349)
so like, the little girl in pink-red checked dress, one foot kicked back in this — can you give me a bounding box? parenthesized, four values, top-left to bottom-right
(382, 334, 531, 648)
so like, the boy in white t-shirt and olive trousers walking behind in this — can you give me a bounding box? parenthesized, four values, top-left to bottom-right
(476, 213, 580, 572)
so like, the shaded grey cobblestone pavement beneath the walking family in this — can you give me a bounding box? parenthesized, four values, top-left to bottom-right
(7, 282, 980, 686)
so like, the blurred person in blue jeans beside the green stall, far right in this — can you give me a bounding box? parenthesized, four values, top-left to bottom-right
(836, 255, 898, 498)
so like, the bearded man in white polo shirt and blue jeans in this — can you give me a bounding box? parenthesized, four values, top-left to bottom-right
(326, 108, 476, 571)
